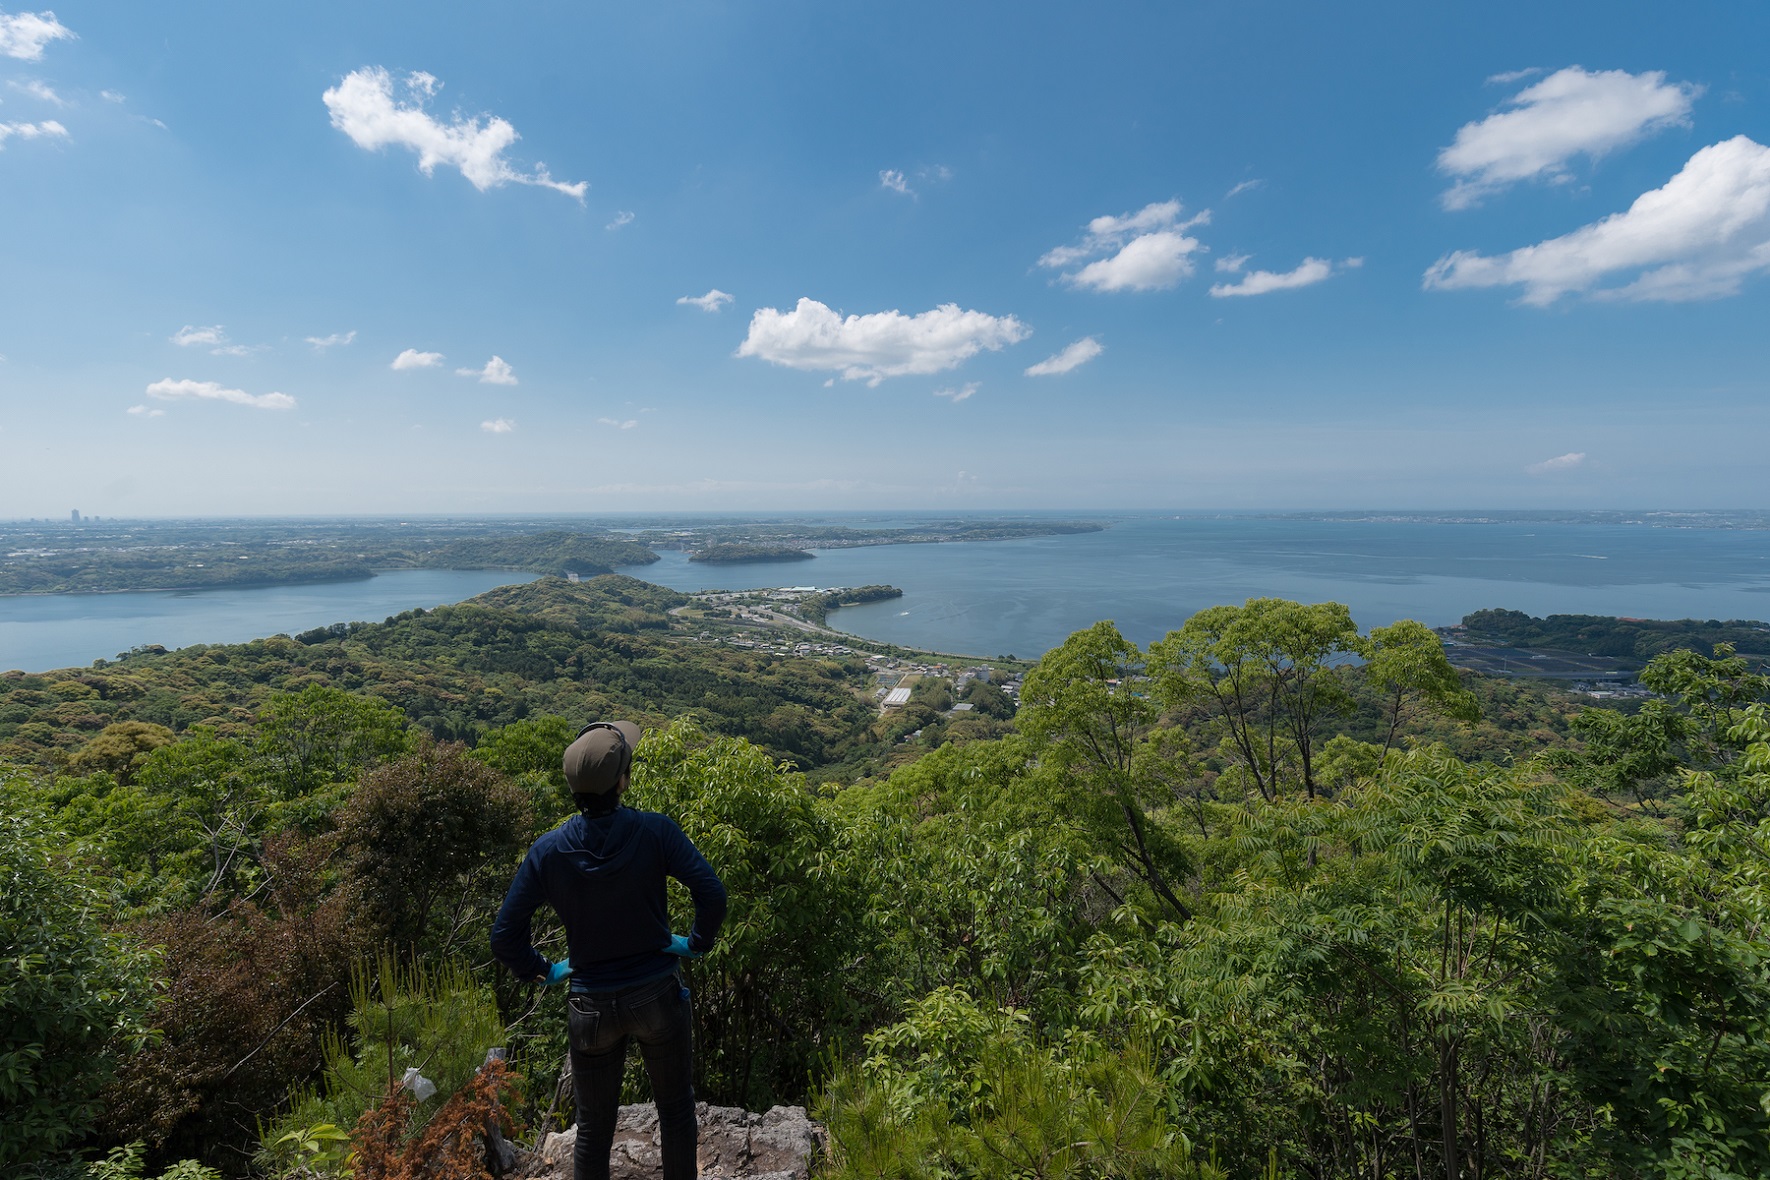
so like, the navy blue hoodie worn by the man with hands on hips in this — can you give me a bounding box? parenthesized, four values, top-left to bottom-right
(492, 807, 726, 991)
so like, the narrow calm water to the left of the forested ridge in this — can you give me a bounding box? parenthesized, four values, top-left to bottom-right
(0, 570, 535, 672)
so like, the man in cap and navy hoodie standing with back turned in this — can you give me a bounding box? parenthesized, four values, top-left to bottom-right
(492, 722, 726, 1180)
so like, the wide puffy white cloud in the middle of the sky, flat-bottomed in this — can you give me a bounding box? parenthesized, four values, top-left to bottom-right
(738, 299, 1032, 386)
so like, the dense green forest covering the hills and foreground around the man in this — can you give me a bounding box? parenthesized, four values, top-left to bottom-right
(0, 590, 1770, 1180)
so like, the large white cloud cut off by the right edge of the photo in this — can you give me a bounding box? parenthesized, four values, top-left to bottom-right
(1425, 134, 1770, 306)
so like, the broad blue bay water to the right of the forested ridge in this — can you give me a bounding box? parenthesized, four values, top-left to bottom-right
(634, 515, 1770, 656)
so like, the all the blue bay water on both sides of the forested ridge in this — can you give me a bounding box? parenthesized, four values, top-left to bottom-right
(0, 515, 1770, 670)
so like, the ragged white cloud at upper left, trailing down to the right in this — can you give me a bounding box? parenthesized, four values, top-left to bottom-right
(320, 67, 589, 202)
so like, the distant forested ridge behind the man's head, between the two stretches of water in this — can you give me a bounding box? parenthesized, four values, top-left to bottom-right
(0, 575, 873, 770)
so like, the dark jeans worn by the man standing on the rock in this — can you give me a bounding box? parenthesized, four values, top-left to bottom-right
(566, 975, 699, 1180)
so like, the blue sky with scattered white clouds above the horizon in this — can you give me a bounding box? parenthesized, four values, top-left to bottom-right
(0, 0, 1770, 517)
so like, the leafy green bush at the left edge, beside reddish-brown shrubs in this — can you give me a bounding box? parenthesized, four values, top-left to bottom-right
(0, 799, 154, 1173)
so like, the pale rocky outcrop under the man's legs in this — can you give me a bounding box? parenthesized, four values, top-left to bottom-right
(515, 1102, 828, 1180)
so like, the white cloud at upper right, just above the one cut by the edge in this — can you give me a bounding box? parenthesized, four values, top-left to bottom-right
(1437, 65, 1703, 209)
